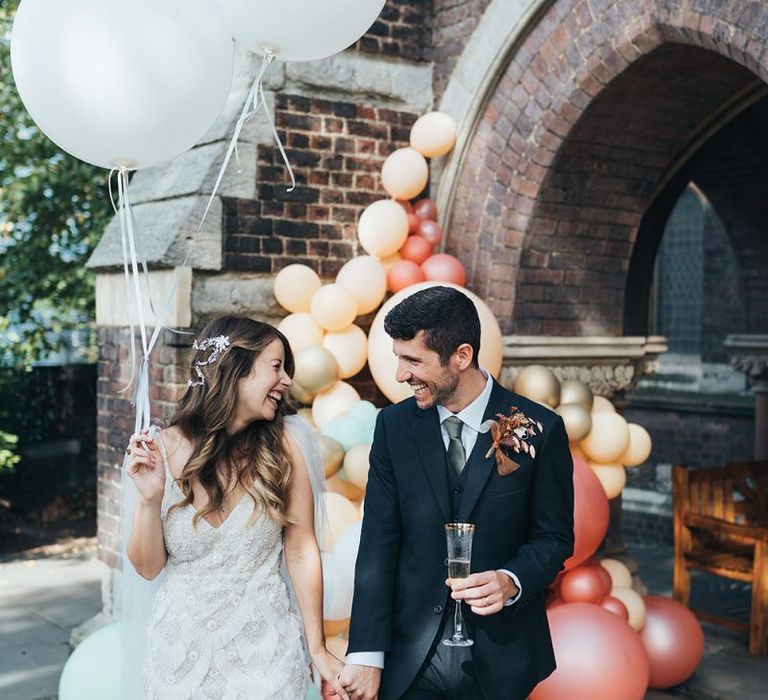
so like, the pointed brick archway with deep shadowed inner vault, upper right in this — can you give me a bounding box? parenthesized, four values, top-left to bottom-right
(440, 0, 768, 335)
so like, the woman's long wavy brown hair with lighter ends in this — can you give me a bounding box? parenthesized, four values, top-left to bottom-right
(170, 316, 294, 527)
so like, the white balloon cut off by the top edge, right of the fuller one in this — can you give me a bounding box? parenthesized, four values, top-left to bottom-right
(219, 0, 385, 61)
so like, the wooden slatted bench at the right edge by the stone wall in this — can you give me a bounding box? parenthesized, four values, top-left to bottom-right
(672, 461, 768, 654)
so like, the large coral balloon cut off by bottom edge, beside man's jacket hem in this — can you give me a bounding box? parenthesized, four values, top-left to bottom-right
(529, 603, 649, 700)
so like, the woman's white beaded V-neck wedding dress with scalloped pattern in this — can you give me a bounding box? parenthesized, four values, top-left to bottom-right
(144, 462, 309, 700)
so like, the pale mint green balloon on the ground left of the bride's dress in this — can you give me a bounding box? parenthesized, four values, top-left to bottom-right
(59, 622, 121, 700)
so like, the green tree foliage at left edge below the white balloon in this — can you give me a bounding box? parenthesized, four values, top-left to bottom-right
(0, 0, 112, 370)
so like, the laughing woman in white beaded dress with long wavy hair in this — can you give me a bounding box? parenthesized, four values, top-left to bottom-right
(126, 316, 347, 700)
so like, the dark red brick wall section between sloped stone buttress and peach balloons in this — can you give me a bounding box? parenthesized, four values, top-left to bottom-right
(224, 94, 418, 278)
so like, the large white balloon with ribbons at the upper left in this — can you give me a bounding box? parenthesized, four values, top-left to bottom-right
(11, 0, 233, 169)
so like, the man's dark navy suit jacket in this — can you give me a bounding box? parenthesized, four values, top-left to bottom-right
(348, 383, 573, 700)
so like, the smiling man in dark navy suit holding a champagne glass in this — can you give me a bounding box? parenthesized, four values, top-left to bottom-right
(340, 287, 573, 700)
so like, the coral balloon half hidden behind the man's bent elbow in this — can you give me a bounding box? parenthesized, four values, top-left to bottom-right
(565, 453, 608, 569)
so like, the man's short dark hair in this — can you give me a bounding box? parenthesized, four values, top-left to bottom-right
(384, 287, 480, 367)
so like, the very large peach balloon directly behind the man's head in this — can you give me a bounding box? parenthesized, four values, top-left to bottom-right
(368, 282, 504, 403)
